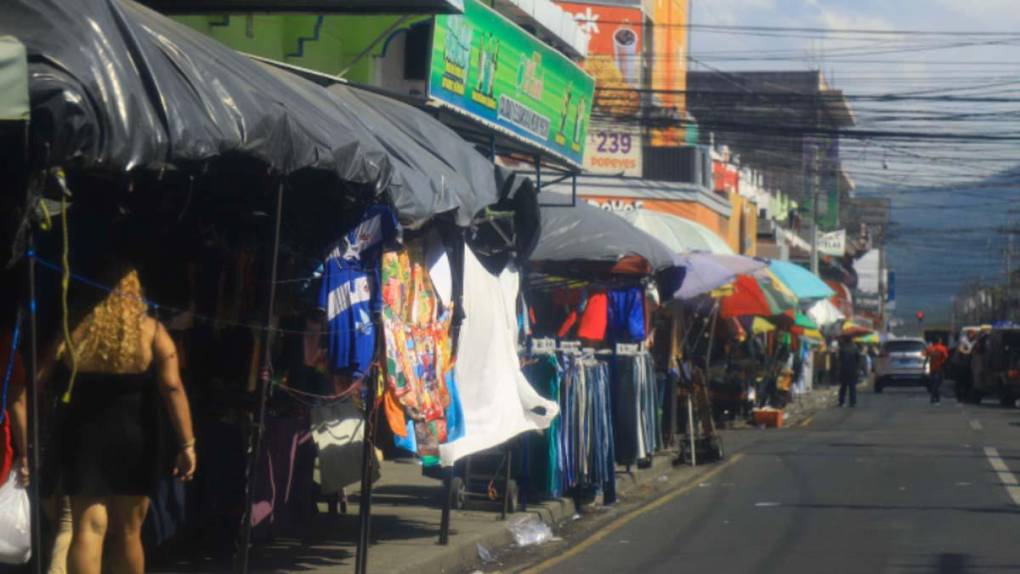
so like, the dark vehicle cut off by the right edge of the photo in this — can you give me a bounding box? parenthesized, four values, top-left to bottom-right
(967, 328, 1020, 406)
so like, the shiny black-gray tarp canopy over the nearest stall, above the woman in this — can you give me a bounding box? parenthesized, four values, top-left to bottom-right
(0, 0, 497, 225)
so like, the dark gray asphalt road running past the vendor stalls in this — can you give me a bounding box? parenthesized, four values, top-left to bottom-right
(539, 389, 1020, 574)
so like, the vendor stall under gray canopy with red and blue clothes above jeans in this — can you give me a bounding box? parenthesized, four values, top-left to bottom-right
(526, 204, 682, 504)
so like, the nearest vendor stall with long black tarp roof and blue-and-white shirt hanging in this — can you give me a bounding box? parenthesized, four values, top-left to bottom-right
(0, 0, 530, 571)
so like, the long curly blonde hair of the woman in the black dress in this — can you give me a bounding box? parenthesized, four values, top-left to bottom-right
(59, 269, 148, 373)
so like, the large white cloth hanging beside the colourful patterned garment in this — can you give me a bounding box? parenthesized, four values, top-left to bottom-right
(440, 249, 559, 466)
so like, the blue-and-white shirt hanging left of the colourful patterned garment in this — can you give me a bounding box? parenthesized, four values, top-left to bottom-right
(319, 205, 400, 376)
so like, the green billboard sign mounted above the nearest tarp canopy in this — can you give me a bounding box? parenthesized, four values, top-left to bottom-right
(428, 0, 595, 165)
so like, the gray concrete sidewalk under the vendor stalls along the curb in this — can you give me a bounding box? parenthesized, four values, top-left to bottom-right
(189, 386, 835, 574)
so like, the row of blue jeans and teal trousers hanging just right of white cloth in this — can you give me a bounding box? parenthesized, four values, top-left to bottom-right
(525, 350, 616, 504)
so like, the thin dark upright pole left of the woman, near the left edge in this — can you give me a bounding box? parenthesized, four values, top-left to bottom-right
(26, 236, 43, 574)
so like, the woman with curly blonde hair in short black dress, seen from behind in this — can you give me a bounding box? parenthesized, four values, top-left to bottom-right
(40, 265, 197, 574)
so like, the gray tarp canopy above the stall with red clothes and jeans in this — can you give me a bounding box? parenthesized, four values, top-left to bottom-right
(530, 200, 675, 271)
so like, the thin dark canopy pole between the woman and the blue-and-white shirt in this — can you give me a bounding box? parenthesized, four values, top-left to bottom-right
(235, 180, 284, 574)
